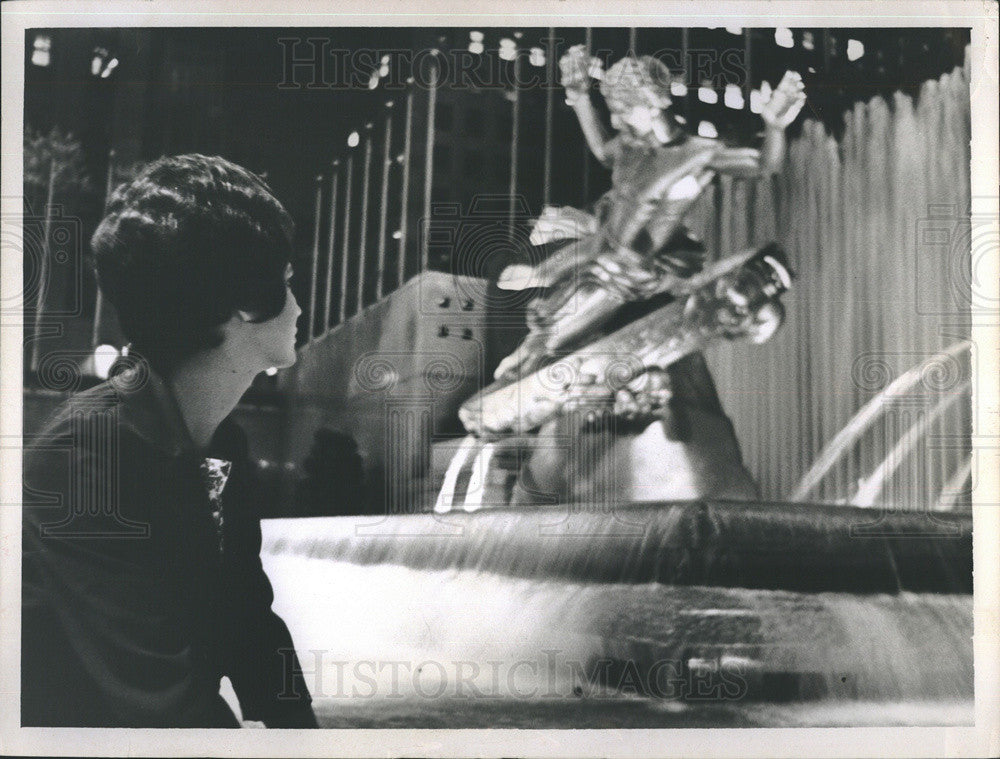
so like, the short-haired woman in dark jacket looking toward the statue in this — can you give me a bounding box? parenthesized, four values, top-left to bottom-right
(21, 155, 316, 727)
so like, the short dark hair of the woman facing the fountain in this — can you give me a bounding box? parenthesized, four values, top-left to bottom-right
(91, 154, 294, 371)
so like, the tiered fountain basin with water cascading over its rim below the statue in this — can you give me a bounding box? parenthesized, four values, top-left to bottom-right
(262, 503, 972, 727)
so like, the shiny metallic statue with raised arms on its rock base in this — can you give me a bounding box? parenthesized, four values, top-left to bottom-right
(436, 45, 805, 511)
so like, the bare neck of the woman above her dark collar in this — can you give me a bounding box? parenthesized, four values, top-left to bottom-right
(166, 355, 256, 450)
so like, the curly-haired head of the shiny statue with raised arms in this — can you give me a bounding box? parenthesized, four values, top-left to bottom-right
(601, 55, 670, 135)
